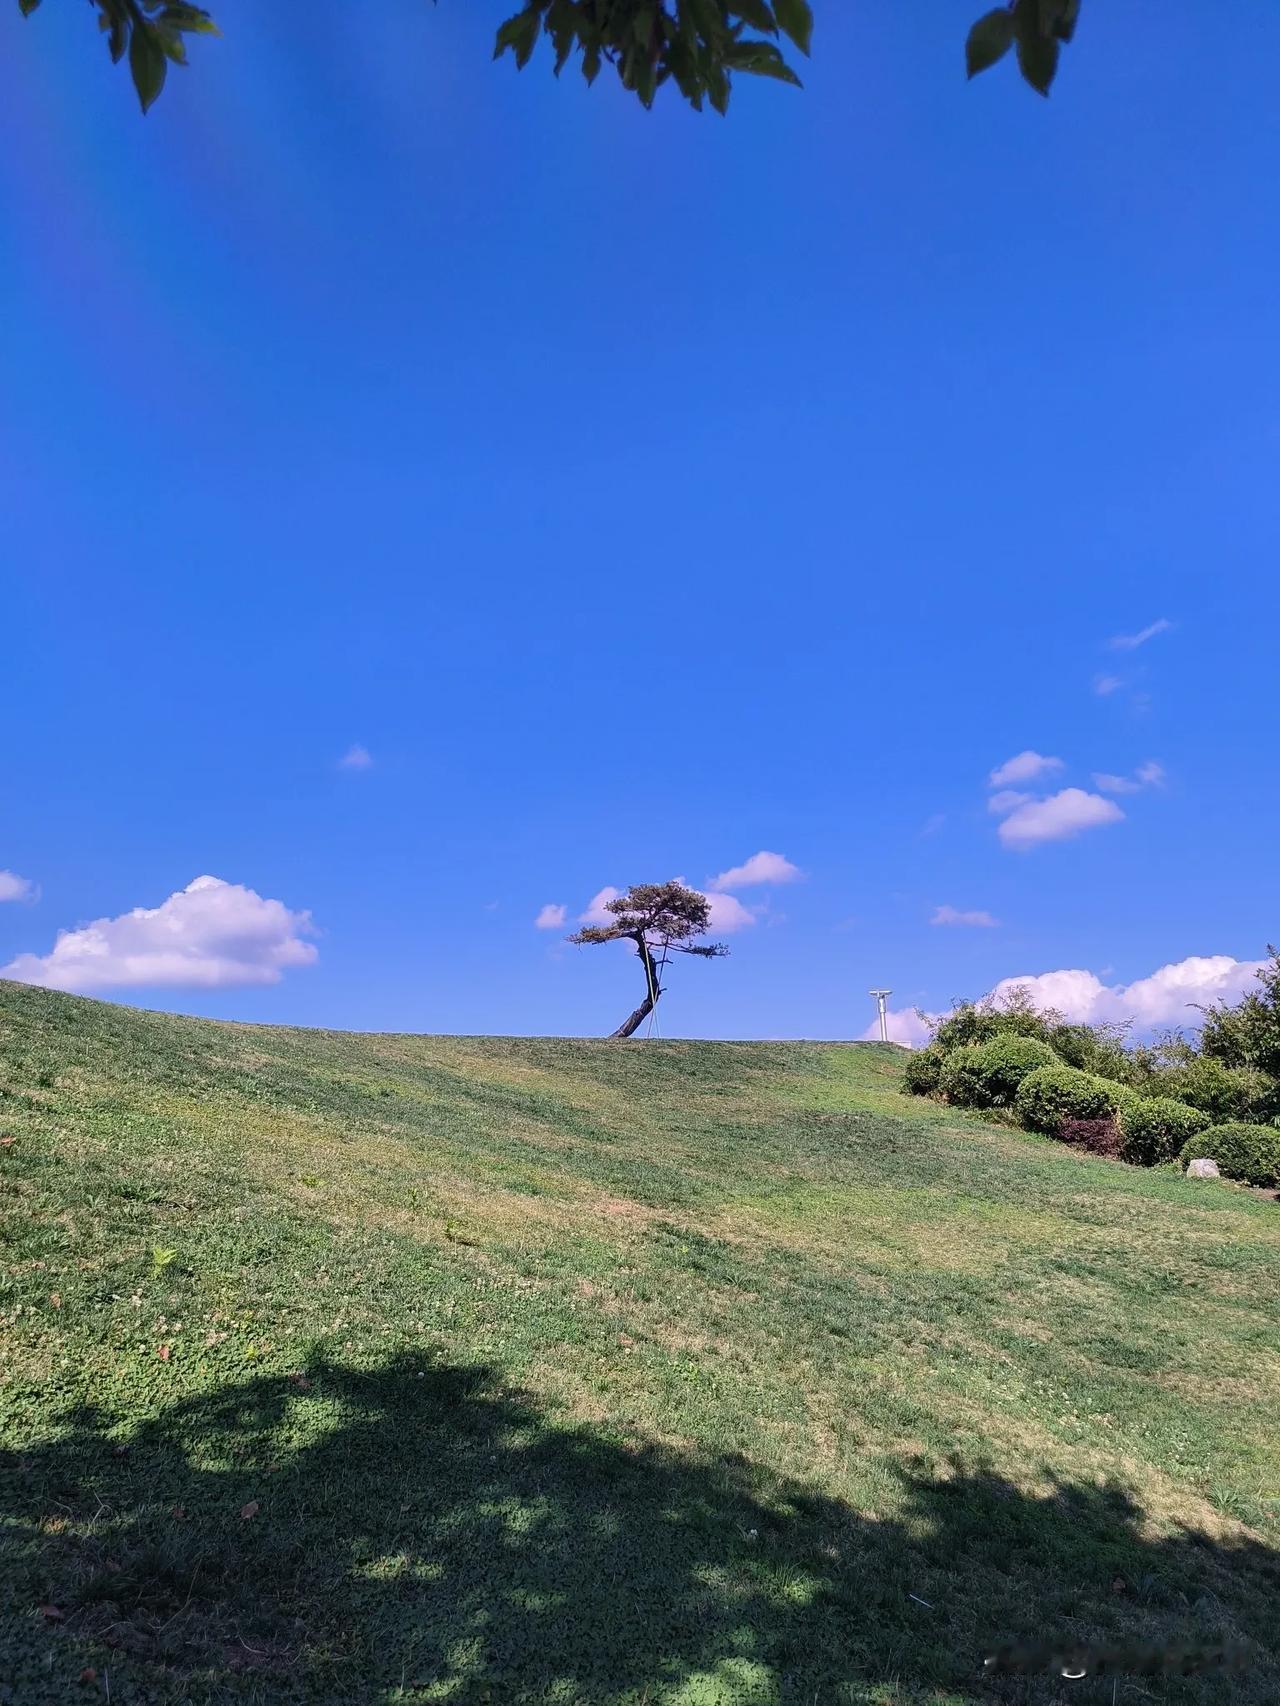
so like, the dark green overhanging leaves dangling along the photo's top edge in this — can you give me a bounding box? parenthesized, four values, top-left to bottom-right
(17, 0, 1080, 113)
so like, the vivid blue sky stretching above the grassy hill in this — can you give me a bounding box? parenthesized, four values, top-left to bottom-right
(0, 0, 1280, 1036)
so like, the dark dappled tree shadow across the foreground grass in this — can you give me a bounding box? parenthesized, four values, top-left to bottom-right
(0, 1355, 1280, 1706)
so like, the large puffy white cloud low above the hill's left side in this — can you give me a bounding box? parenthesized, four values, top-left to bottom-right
(0, 877, 316, 993)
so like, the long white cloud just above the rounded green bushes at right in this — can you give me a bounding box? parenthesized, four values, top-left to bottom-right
(992, 954, 1265, 1030)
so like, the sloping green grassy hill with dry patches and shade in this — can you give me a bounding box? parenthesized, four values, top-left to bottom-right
(0, 984, 1280, 1706)
